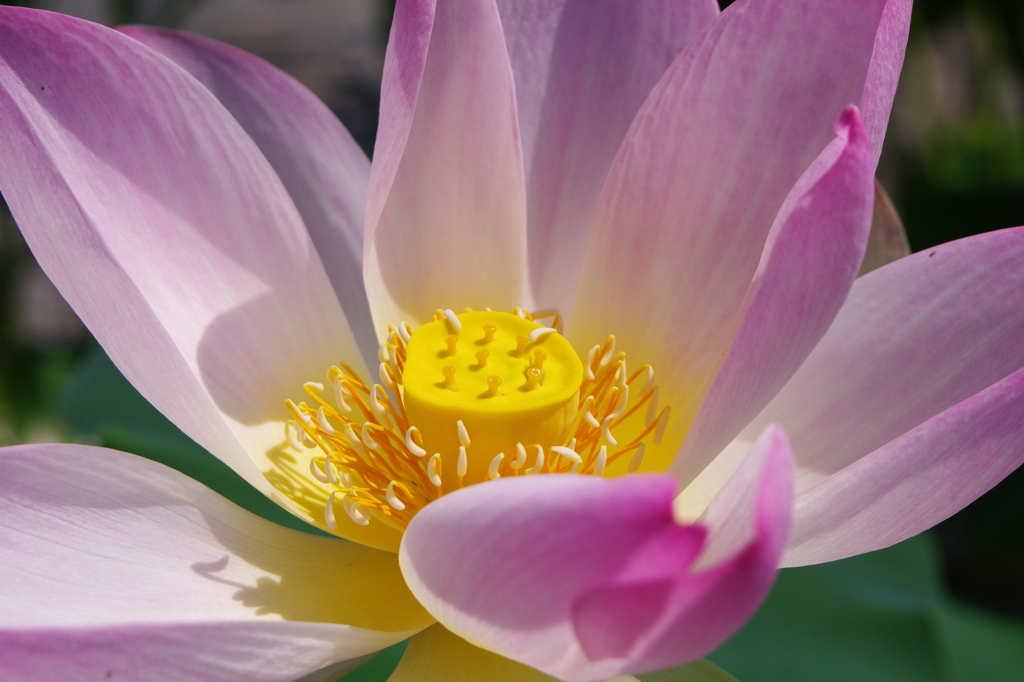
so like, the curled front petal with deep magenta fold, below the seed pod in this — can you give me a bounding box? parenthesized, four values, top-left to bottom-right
(399, 421, 792, 680)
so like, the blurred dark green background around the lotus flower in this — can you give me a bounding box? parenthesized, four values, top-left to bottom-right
(0, 0, 1024, 682)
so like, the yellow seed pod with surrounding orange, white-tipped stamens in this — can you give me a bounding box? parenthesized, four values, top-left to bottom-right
(285, 308, 670, 535)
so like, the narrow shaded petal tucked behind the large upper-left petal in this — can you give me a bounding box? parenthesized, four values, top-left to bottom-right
(118, 26, 377, 361)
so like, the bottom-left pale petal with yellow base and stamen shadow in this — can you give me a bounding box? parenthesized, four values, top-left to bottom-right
(0, 444, 430, 682)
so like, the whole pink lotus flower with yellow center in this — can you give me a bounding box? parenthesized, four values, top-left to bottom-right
(0, 0, 1024, 682)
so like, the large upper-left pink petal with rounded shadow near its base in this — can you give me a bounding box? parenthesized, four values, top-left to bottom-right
(0, 7, 361, 503)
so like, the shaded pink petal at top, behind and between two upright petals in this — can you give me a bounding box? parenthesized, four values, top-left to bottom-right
(498, 0, 719, 313)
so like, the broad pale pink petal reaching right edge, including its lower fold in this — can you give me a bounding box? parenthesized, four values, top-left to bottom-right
(741, 227, 1024, 563)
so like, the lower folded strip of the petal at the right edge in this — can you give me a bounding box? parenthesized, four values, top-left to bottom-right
(783, 369, 1024, 566)
